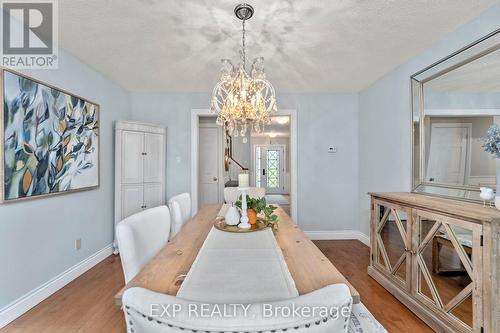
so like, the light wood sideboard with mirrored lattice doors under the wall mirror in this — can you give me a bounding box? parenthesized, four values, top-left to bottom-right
(368, 193, 500, 333)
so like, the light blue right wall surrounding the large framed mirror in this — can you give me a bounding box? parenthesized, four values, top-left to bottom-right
(359, 4, 500, 233)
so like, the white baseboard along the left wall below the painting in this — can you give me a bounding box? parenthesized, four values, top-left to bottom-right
(0, 244, 113, 328)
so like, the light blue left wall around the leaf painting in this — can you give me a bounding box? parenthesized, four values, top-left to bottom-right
(0, 50, 130, 309)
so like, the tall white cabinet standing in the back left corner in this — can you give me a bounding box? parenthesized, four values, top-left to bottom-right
(115, 121, 167, 247)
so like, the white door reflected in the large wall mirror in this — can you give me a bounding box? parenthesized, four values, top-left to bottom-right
(426, 123, 471, 185)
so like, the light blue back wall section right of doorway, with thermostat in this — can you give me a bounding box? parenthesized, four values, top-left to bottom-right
(278, 94, 358, 231)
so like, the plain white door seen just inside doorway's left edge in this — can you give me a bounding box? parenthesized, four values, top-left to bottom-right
(198, 124, 223, 207)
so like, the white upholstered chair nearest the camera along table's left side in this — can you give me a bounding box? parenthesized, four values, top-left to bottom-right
(116, 206, 170, 283)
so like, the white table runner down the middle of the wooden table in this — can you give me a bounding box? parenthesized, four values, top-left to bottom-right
(177, 228, 299, 304)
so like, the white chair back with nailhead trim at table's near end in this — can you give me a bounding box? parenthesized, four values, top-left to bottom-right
(122, 284, 352, 333)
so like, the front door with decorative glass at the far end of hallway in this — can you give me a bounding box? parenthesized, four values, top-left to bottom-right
(255, 146, 285, 194)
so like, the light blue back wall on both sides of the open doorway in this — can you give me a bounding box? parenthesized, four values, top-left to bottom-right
(131, 93, 358, 231)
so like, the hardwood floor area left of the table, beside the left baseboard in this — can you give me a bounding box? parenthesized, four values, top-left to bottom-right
(0, 255, 125, 333)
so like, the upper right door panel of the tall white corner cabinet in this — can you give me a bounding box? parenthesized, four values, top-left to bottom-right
(144, 133, 165, 182)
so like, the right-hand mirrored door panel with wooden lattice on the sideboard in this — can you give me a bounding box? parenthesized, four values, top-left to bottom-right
(415, 213, 475, 328)
